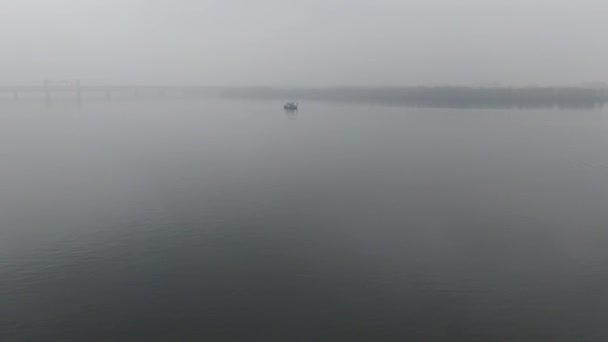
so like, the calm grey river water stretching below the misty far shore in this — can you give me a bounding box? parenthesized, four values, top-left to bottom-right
(0, 100, 608, 341)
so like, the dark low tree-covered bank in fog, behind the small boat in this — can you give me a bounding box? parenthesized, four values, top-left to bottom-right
(220, 86, 608, 108)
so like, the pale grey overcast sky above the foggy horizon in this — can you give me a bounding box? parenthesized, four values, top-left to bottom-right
(0, 0, 608, 86)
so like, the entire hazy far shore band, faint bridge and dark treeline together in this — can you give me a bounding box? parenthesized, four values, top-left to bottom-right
(0, 83, 608, 109)
